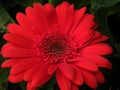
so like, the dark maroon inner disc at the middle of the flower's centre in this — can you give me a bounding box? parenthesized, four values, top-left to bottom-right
(42, 34, 68, 57)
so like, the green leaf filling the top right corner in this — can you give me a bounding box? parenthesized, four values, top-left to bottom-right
(91, 0, 120, 13)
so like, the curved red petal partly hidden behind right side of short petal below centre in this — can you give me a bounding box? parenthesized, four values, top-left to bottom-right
(71, 64, 83, 85)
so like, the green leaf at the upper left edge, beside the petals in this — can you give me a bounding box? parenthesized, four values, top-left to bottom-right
(0, 2, 14, 33)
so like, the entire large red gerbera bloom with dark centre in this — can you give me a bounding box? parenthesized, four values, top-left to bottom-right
(1, 2, 112, 90)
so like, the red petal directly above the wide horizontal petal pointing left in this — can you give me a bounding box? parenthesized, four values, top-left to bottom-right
(4, 33, 33, 48)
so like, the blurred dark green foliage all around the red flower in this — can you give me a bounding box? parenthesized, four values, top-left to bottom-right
(0, 0, 120, 90)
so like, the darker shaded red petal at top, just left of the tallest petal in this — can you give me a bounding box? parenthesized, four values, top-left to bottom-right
(44, 4, 58, 30)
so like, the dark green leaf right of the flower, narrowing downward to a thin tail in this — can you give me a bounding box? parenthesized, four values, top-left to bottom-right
(95, 8, 116, 44)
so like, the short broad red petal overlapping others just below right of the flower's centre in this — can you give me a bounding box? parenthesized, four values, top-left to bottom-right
(58, 63, 74, 80)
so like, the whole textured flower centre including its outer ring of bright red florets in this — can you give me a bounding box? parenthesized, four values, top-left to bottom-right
(35, 34, 78, 63)
